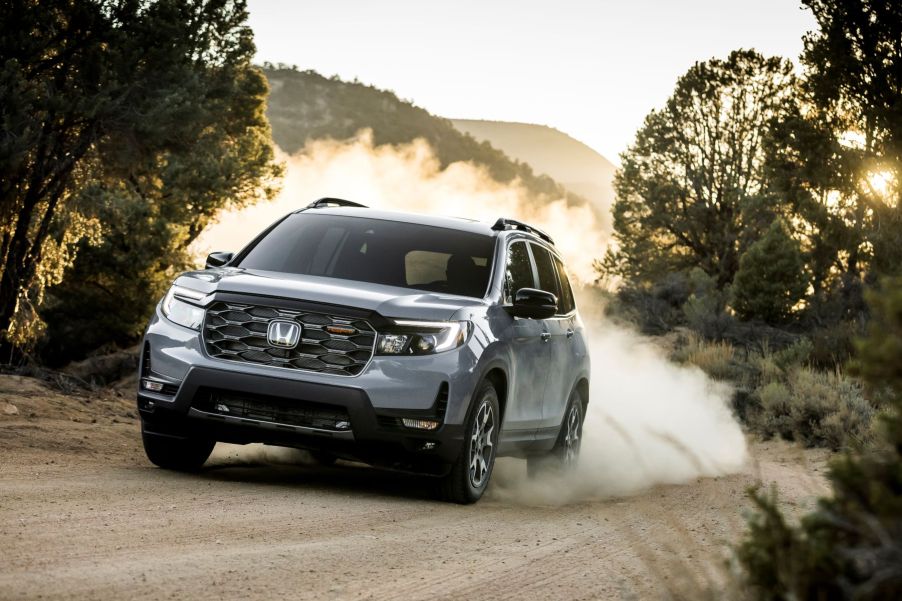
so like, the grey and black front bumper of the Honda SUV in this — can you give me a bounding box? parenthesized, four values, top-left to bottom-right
(138, 311, 477, 472)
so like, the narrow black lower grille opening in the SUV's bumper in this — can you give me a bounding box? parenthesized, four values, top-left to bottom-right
(192, 389, 351, 432)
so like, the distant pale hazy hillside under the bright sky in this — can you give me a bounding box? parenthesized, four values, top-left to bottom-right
(451, 119, 616, 212)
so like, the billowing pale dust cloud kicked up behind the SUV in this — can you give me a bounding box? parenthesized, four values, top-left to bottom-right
(201, 131, 746, 504)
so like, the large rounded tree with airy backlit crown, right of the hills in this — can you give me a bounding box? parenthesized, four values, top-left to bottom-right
(605, 50, 795, 288)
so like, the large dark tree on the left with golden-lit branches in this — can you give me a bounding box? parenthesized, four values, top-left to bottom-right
(0, 0, 277, 354)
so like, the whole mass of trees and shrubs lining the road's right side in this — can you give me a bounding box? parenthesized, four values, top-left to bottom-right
(597, 0, 902, 599)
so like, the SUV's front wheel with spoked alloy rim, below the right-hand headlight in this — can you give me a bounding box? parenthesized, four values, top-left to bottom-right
(442, 381, 501, 504)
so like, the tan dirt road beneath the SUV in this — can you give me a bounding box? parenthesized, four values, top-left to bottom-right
(0, 376, 827, 599)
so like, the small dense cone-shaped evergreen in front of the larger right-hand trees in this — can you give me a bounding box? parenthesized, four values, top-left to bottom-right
(732, 220, 808, 324)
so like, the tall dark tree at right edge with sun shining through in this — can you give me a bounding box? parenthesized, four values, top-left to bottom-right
(769, 0, 902, 307)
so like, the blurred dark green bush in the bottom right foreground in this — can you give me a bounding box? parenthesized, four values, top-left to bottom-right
(738, 279, 902, 601)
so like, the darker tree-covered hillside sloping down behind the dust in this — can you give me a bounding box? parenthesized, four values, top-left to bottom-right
(264, 66, 582, 202)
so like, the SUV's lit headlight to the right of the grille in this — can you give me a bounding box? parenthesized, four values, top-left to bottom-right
(376, 319, 471, 355)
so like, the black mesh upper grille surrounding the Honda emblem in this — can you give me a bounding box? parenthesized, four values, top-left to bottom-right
(204, 301, 376, 376)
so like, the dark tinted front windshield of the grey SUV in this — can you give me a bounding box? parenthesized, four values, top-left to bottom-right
(238, 212, 495, 298)
